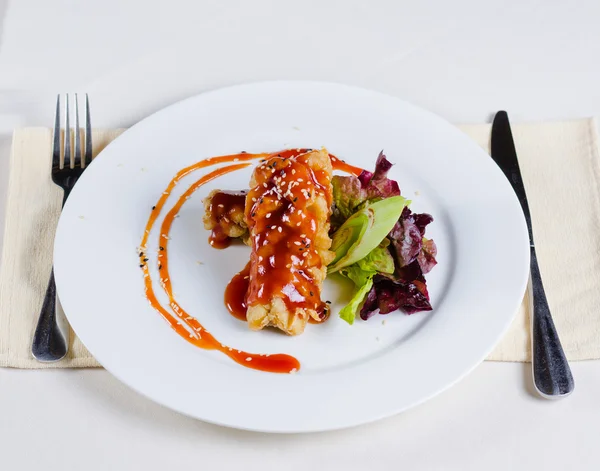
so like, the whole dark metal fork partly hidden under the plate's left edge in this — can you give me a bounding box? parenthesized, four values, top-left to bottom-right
(31, 94, 92, 362)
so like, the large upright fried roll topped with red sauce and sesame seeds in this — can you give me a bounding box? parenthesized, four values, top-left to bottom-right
(245, 149, 334, 335)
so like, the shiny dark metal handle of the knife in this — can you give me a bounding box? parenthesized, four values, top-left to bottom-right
(529, 246, 575, 399)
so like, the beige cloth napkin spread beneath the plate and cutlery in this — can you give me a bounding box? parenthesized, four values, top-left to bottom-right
(0, 123, 600, 368)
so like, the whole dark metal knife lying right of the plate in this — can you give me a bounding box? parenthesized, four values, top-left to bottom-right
(492, 111, 575, 399)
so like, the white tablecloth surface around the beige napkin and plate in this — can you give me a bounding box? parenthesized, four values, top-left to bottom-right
(0, 0, 600, 471)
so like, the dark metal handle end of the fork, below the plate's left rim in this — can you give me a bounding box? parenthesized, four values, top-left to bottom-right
(31, 268, 68, 362)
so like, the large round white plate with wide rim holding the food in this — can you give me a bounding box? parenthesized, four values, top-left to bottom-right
(54, 82, 529, 432)
